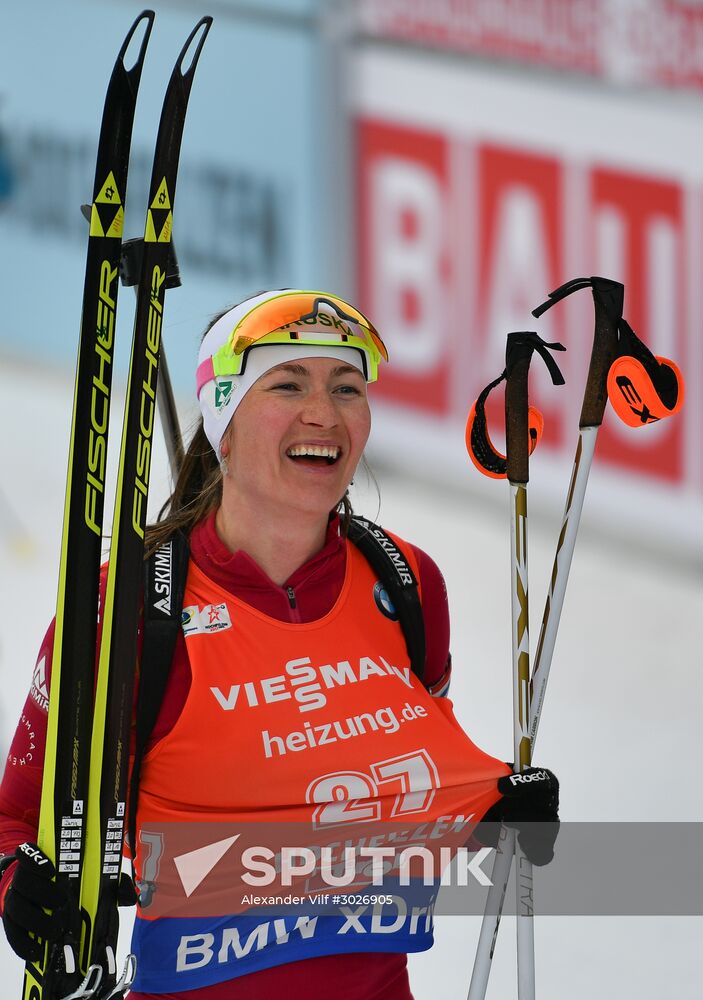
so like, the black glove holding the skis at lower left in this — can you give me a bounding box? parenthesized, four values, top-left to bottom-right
(0, 844, 80, 962)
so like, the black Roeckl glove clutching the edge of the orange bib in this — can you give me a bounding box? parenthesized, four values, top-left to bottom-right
(474, 764, 559, 865)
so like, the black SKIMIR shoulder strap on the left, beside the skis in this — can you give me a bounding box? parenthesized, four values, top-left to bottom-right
(128, 531, 190, 857)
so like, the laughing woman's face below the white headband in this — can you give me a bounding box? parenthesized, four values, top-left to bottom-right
(221, 357, 371, 518)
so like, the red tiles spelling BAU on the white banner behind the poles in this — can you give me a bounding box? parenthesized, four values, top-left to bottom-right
(357, 119, 700, 485)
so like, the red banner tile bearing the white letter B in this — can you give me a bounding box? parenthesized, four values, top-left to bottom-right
(358, 122, 453, 413)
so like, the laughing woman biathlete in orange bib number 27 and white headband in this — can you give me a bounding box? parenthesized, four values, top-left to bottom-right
(0, 289, 558, 1000)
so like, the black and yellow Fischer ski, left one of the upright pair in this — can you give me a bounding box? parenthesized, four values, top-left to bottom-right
(23, 10, 154, 1000)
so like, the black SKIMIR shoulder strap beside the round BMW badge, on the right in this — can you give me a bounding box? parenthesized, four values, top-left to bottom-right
(348, 516, 425, 681)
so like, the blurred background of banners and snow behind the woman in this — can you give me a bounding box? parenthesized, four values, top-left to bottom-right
(0, 0, 703, 1000)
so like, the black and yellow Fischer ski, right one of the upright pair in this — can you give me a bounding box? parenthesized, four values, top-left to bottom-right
(80, 17, 212, 998)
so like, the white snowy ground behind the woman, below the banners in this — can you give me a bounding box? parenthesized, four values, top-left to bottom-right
(0, 358, 703, 1000)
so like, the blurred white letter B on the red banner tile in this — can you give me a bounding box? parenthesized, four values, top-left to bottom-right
(371, 157, 444, 371)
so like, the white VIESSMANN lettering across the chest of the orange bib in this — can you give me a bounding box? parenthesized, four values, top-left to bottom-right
(212, 652, 413, 716)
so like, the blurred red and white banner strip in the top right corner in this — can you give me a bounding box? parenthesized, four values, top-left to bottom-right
(358, 0, 703, 89)
